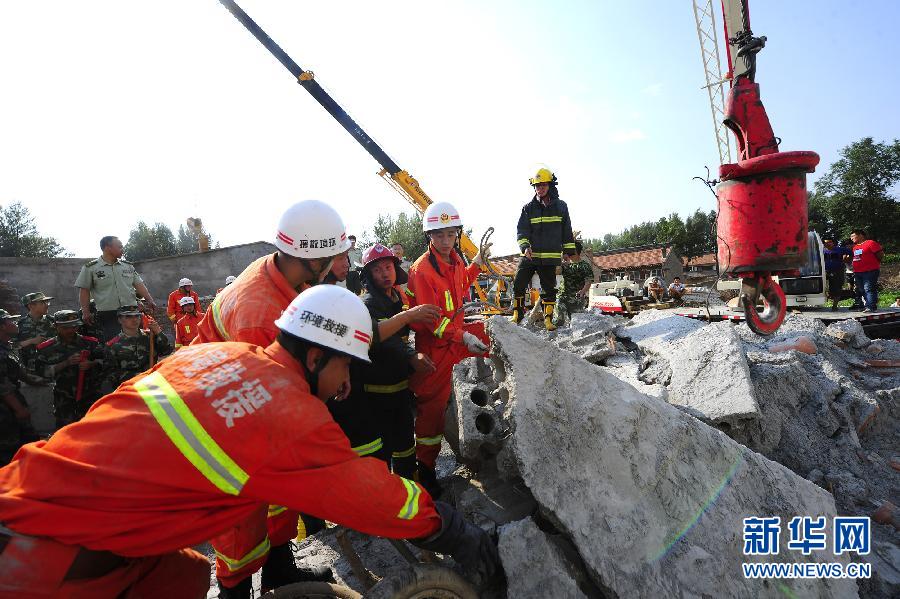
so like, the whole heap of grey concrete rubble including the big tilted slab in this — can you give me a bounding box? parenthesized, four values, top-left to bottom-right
(446, 311, 900, 597)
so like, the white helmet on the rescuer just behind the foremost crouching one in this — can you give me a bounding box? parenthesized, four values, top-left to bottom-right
(275, 200, 350, 259)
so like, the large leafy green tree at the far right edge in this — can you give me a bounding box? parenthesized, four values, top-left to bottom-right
(810, 137, 900, 249)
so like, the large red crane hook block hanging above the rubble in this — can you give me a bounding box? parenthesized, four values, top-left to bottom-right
(716, 0, 819, 335)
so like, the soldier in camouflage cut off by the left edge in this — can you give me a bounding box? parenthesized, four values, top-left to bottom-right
(0, 310, 38, 466)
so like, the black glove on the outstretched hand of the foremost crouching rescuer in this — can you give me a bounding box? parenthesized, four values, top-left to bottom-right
(410, 501, 502, 584)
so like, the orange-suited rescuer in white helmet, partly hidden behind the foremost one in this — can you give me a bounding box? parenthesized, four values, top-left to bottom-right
(191, 200, 440, 599)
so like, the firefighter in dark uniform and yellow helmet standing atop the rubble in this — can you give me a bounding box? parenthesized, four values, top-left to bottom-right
(512, 168, 575, 331)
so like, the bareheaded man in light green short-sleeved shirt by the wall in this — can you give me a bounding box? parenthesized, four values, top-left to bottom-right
(75, 235, 156, 341)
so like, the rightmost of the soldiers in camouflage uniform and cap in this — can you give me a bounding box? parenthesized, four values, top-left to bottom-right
(106, 306, 172, 388)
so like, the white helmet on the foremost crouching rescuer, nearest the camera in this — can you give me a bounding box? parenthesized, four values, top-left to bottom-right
(275, 285, 372, 362)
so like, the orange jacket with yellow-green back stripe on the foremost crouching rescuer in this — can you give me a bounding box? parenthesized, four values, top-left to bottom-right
(0, 343, 441, 557)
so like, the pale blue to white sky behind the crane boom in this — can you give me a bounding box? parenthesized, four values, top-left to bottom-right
(0, 0, 900, 256)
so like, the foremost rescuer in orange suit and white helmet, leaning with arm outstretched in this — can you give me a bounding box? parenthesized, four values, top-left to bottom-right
(0, 286, 499, 599)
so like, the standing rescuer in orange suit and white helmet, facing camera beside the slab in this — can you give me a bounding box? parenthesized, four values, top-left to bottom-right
(407, 202, 490, 494)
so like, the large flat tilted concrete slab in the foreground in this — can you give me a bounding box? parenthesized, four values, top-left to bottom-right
(455, 318, 856, 597)
